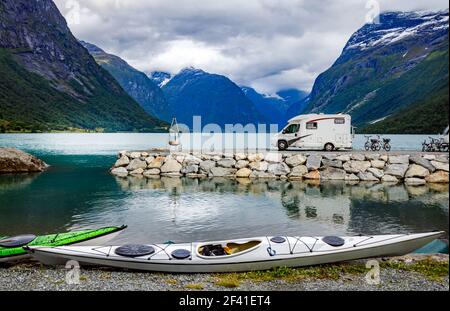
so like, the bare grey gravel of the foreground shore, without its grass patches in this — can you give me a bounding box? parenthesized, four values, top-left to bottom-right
(0, 255, 449, 291)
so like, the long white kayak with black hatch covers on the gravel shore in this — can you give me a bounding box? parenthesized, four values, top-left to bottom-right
(26, 232, 443, 273)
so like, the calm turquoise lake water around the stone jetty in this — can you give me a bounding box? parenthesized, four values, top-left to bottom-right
(0, 134, 449, 243)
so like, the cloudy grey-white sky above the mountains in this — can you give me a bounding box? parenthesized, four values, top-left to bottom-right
(55, 0, 448, 93)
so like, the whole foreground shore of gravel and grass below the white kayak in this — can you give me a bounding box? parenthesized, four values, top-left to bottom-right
(0, 254, 449, 291)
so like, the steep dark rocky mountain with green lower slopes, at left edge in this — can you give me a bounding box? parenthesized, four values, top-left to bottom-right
(0, 0, 166, 131)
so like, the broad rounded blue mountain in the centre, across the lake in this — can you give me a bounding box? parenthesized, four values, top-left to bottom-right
(162, 68, 266, 128)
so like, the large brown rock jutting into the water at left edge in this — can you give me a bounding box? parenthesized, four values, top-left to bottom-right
(0, 148, 49, 174)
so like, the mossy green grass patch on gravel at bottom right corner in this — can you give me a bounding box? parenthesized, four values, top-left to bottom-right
(380, 259, 449, 281)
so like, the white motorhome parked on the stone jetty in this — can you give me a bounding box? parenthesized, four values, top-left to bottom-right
(272, 114, 354, 151)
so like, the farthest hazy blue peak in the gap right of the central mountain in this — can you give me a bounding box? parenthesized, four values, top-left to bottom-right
(241, 86, 307, 127)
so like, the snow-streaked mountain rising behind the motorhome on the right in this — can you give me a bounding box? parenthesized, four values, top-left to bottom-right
(298, 10, 449, 131)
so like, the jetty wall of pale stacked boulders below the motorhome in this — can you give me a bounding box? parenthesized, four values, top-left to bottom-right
(111, 151, 449, 186)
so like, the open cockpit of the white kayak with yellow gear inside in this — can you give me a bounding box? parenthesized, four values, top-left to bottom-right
(197, 240, 262, 258)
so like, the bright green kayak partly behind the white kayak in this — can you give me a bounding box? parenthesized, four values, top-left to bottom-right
(0, 226, 127, 263)
